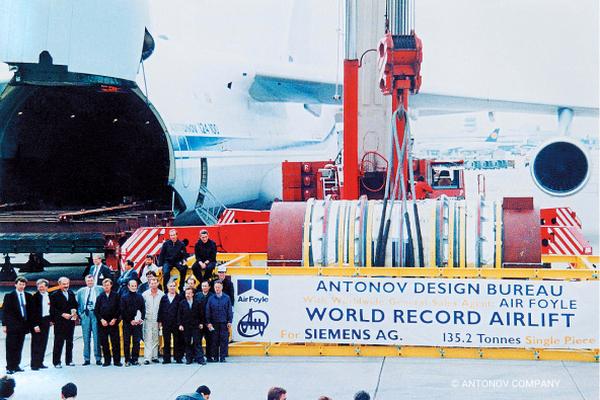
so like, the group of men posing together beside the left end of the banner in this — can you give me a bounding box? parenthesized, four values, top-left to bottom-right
(2, 229, 234, 374)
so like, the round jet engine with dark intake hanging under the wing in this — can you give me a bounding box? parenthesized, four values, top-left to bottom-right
(531, 139, 590, 196)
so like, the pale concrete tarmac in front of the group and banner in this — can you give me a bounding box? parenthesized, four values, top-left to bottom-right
(0, 327, 600, 400)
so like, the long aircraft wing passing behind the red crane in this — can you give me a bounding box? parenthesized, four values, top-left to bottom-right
(249, 73, 599, 117)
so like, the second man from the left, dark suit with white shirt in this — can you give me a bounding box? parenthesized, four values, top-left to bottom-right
(31, 279, 51, 371)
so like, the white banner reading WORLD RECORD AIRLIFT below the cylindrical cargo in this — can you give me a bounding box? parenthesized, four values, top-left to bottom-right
(233, 276, 599, 349)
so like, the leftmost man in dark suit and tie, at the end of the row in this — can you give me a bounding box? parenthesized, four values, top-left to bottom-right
(2, 277, 31, 375)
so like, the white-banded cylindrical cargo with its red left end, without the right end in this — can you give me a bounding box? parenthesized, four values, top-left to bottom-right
(269, 196, 502, 267)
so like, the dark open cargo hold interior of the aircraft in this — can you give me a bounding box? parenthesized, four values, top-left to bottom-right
(0, 84, 171, 209)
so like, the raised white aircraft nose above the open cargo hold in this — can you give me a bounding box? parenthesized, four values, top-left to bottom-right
(0, 0, 148, 81)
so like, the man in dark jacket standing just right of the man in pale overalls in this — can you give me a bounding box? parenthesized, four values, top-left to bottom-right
(158, 280, 183, 364)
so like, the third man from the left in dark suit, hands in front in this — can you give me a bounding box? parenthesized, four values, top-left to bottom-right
(50, 276, 78, 368)
